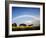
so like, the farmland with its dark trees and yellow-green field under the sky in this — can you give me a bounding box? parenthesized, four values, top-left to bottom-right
(12, 23, 40, 31)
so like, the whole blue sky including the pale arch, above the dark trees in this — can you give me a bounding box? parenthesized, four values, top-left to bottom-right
(12, 7, 40, 24)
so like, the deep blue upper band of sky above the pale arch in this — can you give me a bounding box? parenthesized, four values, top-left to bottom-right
(12, 7, 40, 17)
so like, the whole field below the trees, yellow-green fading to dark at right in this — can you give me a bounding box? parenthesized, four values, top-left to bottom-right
(12, 25, 40, 31)
